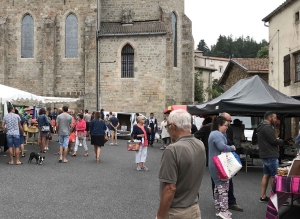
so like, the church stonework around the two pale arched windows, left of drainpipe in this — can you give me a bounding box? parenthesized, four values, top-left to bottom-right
(0, 0, 97, 110)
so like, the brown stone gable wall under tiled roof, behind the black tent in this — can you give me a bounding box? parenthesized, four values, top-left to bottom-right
(224, 65, 269, 90)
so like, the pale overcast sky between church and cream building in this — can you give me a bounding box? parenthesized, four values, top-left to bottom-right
(185, 0, 285, 47)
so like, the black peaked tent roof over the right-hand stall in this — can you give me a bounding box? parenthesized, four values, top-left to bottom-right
(187, 75, 300, 116)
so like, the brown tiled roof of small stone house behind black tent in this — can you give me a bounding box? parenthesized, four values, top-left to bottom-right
(231, 58, 269, 71)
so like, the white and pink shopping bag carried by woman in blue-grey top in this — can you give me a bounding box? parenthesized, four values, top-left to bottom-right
(212, 152, 242, 181)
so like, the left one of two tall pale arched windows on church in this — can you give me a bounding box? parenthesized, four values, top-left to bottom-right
(21, 14, 34, 58)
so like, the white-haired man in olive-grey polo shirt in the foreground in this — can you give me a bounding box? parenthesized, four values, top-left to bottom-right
(156, 109, 206, 219)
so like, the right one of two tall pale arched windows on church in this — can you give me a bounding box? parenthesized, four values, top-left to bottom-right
(65, 14, 78, 58)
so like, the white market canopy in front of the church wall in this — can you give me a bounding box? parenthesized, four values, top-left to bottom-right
(0, 84, 79, 104)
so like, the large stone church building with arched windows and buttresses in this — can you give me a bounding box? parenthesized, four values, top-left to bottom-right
(0, 0, 194, 118)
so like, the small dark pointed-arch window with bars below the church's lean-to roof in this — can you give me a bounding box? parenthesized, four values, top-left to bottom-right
(121, 44, 134, 78)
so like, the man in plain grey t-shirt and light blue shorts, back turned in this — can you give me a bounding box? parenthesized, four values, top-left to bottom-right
(56, 106, 72, 163)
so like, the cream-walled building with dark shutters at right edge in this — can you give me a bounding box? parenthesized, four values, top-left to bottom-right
(262, 0, 300, 96)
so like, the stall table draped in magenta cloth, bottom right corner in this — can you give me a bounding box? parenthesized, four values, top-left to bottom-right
(266, 175, 300, 219)
